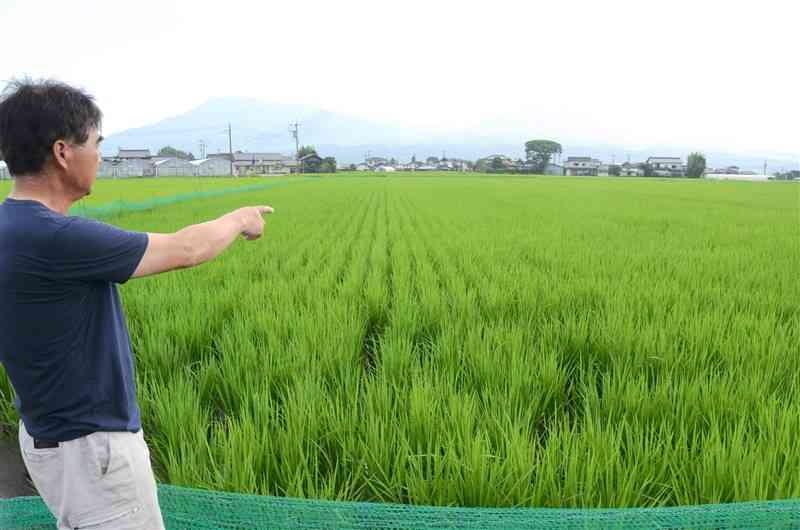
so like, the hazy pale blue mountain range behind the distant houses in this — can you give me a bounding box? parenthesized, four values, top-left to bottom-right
(103, 97, 797, 171)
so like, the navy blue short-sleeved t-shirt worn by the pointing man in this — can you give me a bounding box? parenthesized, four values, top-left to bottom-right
(0, 198, 148, 442)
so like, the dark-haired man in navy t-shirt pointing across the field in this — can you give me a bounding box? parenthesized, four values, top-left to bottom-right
(0, 80, 272, 530)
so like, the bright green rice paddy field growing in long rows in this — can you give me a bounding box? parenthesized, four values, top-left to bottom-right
(0, 175, 800, 507)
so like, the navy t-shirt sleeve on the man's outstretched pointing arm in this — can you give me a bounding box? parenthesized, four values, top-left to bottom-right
(48, 217, 148, 283)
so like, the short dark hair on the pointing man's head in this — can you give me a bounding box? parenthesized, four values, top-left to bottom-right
(0, 79, 103, 176)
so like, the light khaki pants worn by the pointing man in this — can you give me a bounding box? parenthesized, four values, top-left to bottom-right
(19, 422, 164, 530)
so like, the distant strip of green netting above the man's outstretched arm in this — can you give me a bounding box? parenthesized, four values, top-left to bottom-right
(70, 177, 319, 219)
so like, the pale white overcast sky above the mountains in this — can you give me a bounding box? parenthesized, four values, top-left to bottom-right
(0, 0, 800, 155)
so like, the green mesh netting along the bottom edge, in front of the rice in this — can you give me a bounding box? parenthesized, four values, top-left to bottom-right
(0, 485, 800, 530)
